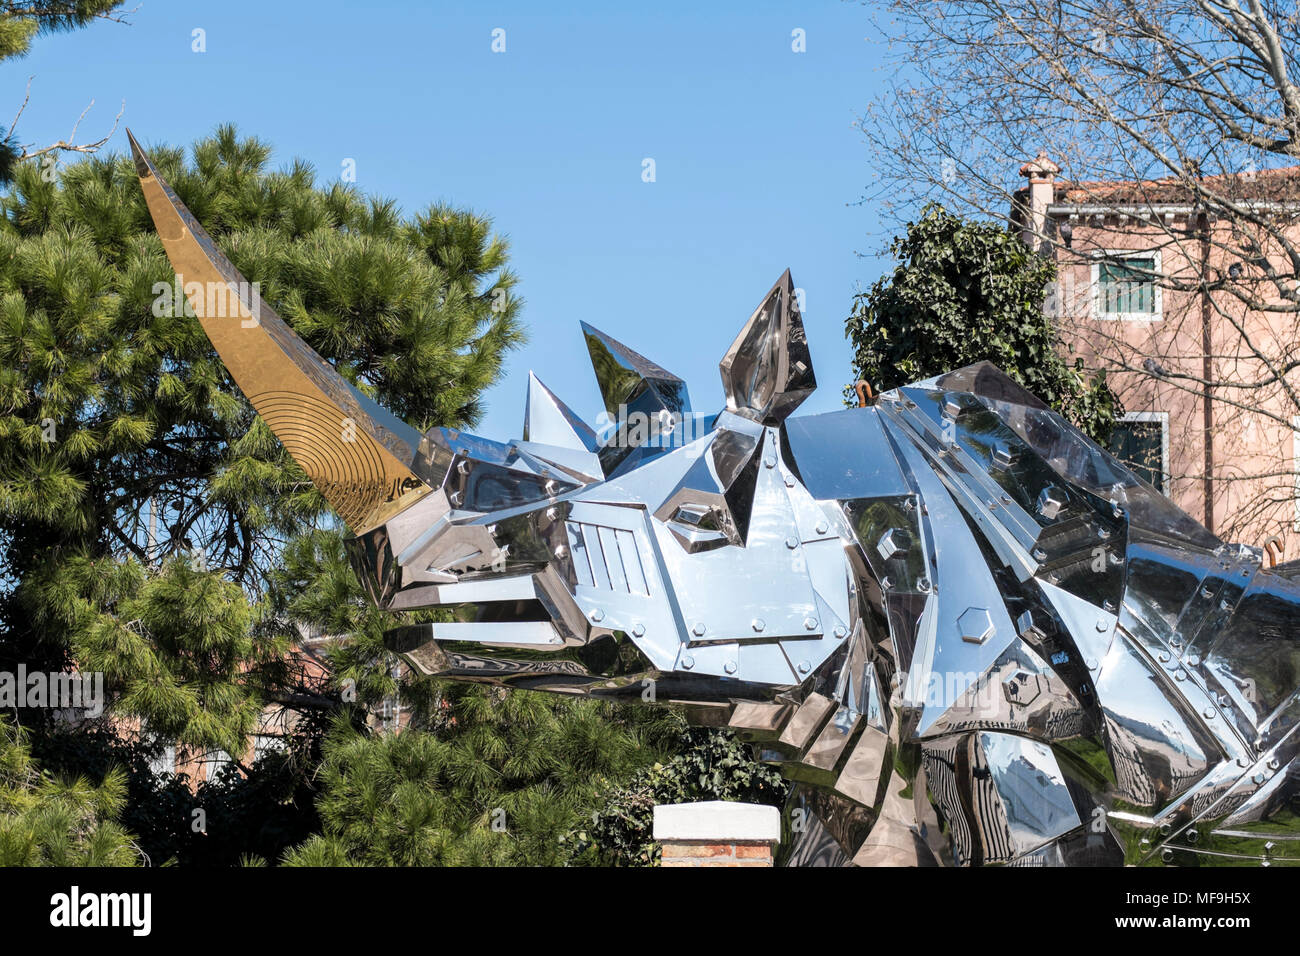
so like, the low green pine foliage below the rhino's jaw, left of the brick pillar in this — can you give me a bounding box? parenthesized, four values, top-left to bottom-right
(285, 685, 683, 866)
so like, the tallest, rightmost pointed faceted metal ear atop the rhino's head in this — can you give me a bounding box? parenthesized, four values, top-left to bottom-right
(719, 269, 816, 424)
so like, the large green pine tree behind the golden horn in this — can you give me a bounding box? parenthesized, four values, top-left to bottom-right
(0, 126, 523, 753)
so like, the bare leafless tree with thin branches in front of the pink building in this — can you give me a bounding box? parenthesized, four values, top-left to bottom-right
(859, 0, 1300, 544)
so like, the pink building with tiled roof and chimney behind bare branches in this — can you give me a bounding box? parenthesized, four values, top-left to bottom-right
(1011, 153, 1300, 558)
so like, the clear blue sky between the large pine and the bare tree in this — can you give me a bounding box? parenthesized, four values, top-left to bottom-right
(4, 0, 887, 438)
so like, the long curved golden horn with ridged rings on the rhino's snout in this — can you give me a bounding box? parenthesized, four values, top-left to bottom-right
(127, 131, 432, 532)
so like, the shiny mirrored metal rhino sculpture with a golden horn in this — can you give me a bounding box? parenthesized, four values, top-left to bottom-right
(131, 130, 1300, 865)
